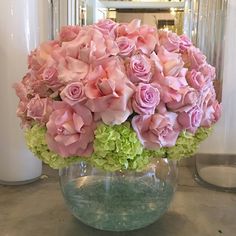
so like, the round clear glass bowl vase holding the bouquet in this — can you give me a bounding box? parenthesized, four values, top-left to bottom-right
(59, 159, 178, 231)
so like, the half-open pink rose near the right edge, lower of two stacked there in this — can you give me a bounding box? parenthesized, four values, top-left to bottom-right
(186, 70, 205, 91)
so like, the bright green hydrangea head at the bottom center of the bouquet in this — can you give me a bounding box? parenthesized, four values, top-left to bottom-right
(91, 122, 149, 171)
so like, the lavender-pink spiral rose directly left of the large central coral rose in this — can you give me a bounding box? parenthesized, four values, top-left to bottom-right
(60, 82, 86, 106)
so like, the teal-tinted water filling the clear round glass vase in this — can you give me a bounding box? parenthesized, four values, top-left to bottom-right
(62, 176, 174, 231)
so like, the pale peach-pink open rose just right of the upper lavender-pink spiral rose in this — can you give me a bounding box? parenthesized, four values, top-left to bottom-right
(157, 46, 184, 76)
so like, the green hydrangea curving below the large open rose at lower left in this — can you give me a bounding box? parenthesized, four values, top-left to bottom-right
(25, 124, 79, 169)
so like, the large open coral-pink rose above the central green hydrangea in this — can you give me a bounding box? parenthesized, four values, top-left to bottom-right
(85, 61, 134, 124)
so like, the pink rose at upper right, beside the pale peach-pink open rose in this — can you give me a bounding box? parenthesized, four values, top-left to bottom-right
(182, 46, 206, 70)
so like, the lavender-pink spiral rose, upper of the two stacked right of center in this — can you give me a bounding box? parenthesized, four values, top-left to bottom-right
(128, 54, 153, 83)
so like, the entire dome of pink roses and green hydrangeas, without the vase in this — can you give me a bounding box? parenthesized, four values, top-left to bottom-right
(14, 20, 221, 171)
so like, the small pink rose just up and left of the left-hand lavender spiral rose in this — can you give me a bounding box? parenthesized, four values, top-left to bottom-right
(42, 66, 63, 91)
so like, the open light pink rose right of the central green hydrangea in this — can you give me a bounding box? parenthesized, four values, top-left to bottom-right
(132, 112, 179, 150)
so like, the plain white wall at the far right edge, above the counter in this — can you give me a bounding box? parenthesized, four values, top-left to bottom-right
(199, 0, 236, 154)
